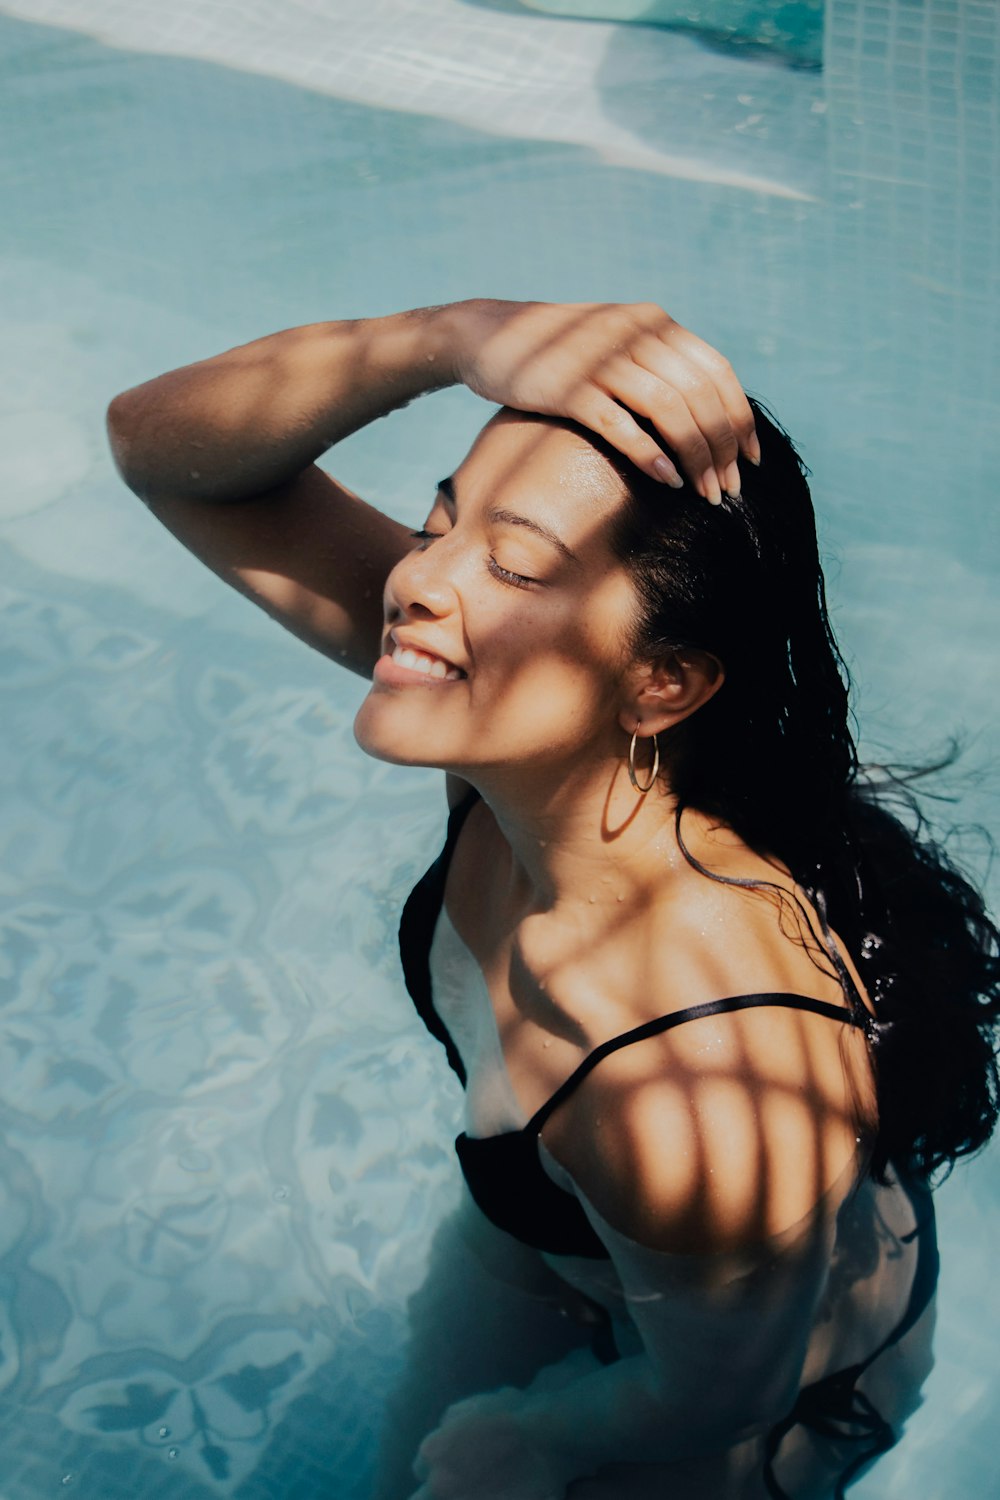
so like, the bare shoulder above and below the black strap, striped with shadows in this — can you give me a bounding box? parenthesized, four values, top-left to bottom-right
(544, 858, 874, 1254)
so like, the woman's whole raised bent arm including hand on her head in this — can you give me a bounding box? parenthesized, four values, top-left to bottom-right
(108, 299, 754, 675)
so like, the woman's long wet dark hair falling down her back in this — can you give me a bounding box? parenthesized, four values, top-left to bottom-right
(586, 402, 1000, 1178)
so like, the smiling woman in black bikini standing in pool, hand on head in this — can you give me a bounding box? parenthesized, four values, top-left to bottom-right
(109, 302, 999, 1500)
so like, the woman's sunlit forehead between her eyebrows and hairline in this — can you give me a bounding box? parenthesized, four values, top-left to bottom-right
(454, 408, 627, 530)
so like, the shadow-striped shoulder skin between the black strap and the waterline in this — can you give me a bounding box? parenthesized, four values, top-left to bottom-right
(544, 1011, 859, 1254)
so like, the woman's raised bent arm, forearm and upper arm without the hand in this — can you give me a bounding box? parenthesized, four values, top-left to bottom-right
(108, 309, 454, 675)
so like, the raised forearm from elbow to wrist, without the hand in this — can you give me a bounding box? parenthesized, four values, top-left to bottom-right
(108, 305, 462, 501)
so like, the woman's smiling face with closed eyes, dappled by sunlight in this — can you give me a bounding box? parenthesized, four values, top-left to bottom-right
(354, 411, 637, 780)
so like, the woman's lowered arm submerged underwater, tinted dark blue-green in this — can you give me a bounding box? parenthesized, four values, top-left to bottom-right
(414, 1253, 816, 1500)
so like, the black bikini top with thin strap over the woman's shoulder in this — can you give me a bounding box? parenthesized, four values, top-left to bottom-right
(399, 792, 868, 1260)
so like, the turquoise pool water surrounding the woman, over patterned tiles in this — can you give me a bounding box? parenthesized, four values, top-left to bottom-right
(0, 0, 1000, 1500)
